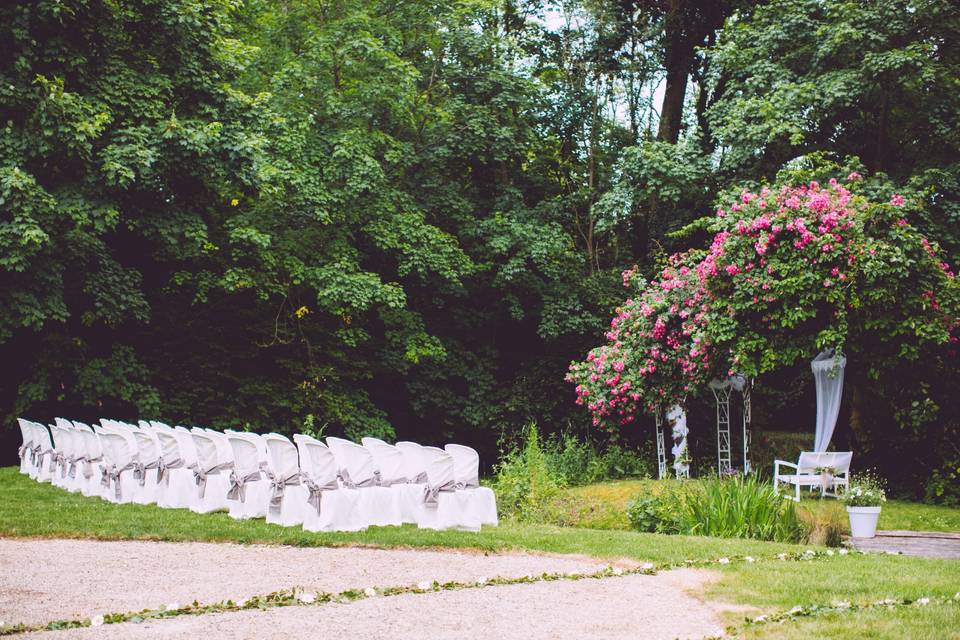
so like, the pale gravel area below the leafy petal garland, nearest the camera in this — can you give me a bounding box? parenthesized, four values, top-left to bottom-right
(24, 569, 721, 640)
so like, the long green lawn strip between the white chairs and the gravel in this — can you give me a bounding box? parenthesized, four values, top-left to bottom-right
(0, 467, 803, 564)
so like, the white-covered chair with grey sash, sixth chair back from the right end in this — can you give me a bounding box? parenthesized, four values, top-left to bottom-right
(293, 433, 366, 531)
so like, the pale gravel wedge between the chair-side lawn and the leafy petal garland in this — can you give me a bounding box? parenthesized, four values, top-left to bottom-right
(0, 539, 603, 624)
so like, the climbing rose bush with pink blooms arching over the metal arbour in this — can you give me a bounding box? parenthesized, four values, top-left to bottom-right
(567, 173, 960, 428)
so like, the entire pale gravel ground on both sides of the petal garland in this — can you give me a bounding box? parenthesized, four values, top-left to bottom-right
(0, 539, 722, 640)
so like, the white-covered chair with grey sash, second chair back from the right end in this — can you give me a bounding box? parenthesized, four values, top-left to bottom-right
(417, 447, 481, 531)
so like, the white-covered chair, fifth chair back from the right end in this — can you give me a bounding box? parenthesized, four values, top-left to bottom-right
(327, 437, 403, 527)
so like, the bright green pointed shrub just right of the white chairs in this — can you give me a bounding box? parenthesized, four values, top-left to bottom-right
(494, 423, 565, 522)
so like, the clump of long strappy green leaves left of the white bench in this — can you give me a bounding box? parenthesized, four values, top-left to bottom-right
(628, 475, 806, 542)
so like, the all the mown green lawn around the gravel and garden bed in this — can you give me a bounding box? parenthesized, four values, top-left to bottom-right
(0, 468, 960, 640)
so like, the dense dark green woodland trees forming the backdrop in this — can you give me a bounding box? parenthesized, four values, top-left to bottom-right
(0, 0, 960, 500)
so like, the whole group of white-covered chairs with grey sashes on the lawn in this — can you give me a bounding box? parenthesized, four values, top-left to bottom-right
(19, 418, 498, 531)
